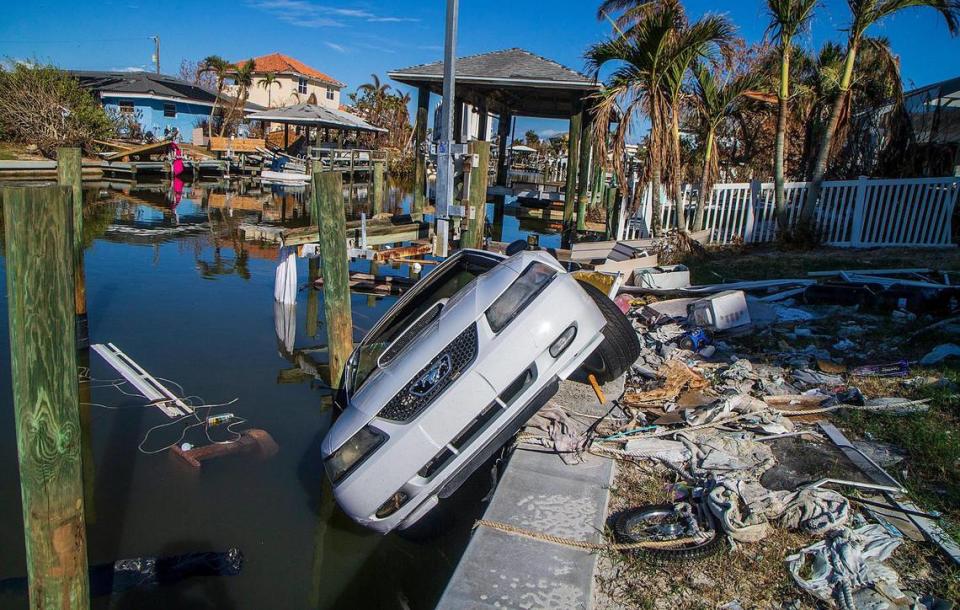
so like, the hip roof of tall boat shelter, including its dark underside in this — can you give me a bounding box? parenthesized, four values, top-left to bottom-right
(388, 48, 600, 118)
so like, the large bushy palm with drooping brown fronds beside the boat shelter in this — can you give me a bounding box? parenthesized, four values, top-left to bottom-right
(586, 0, 732, 235)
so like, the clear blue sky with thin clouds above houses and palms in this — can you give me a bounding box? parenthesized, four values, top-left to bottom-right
(0, 0, 960, 133)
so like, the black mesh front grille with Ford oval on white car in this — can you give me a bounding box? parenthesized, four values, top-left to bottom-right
(377, 324, 477, 422)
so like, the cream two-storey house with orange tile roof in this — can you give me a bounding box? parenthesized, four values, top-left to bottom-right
(229, 53, 346, 108)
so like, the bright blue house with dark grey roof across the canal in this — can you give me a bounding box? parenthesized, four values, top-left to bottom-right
(71, 70, 263, 143)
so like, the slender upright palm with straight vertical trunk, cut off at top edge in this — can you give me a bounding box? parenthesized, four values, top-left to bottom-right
(767, 0, 817, 233)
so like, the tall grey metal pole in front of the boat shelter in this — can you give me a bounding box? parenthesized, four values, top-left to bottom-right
(436, 0, 460, 257)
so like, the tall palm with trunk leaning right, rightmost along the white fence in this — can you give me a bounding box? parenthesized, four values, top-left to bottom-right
(800, 0, 960, 226)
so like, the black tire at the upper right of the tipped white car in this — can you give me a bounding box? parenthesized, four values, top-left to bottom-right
(577, 280, 640, 383)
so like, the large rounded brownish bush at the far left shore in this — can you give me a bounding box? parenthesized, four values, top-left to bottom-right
(0, 62, 113, 157)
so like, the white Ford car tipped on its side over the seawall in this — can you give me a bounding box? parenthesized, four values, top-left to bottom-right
(322, 250, 640, 533)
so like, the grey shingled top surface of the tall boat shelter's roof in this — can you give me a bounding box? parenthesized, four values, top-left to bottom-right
(390, 48, 595, 85)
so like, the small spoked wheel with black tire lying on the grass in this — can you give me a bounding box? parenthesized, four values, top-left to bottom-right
(613, 504, 724, 563)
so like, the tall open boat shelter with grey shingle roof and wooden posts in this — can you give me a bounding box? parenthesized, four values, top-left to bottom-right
(388, 48, 600, 230)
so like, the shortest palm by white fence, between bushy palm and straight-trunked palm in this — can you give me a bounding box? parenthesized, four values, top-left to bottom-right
(693, 63, 763, 231)
